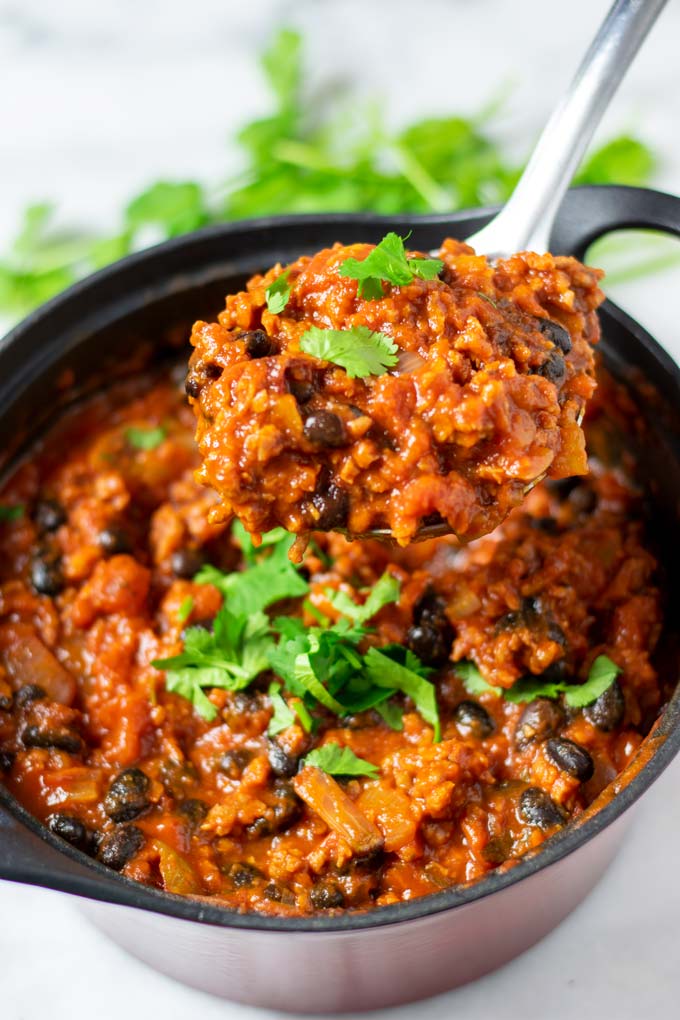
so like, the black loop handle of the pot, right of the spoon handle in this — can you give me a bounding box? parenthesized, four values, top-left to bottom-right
(551, 186, 680, 260)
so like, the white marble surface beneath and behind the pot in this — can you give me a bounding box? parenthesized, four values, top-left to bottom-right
(0, 0, 680, 1020)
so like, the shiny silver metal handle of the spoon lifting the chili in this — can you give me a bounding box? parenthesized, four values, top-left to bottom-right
(468, 0, 668, 257)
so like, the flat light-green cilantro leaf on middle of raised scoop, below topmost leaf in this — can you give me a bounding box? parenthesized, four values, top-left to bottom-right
(300, 325, 398, 378)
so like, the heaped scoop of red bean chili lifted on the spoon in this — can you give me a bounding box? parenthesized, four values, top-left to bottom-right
(189, 240, 603, 545)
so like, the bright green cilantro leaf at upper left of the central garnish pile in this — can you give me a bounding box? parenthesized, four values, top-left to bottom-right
(195, 536, 309, 617)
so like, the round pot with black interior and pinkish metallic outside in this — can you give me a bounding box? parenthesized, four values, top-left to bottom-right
(0, 188, 680, 1012)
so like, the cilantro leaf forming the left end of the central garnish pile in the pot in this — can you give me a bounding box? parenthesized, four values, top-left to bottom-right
(151, 606, 273, 721)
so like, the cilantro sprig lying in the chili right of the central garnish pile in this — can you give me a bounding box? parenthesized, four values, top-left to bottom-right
(456, 655, 621, 708)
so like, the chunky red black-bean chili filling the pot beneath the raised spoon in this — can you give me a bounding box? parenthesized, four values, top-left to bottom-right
(0, 365, 662, 915)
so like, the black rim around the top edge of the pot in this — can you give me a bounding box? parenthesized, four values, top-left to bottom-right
(0, 188, 680, 933)
